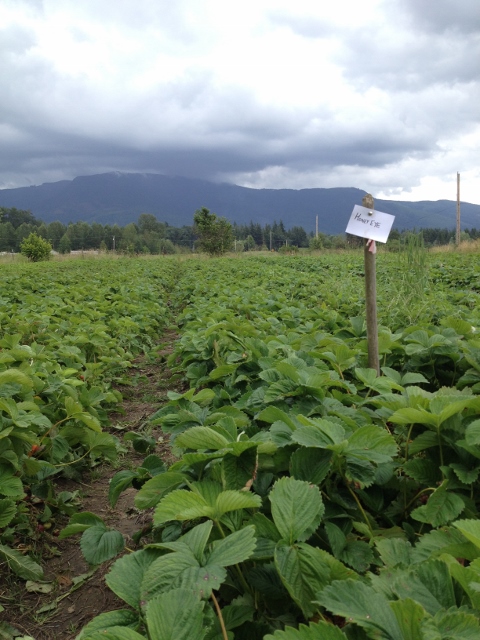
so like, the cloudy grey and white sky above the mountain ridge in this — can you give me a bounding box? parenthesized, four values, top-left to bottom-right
(0, 0, 480, 204)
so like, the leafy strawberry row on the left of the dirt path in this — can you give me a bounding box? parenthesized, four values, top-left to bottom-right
(0, 260, 177, 579)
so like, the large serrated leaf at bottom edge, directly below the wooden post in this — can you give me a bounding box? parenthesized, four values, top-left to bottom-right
(316, 580, 404, 640)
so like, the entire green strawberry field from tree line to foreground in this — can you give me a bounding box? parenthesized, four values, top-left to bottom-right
(0, 251, 480, 640)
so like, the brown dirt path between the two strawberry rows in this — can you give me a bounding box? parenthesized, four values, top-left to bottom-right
(0, 332, 184, 640)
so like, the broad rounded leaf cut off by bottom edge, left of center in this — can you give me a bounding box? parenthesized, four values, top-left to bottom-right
(146, 589, 207, 640)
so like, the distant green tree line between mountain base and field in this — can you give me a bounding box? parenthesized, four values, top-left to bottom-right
(0, 207, 480, 254)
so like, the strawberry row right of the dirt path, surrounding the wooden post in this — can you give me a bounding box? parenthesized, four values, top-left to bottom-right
(76, 258, 480, 640)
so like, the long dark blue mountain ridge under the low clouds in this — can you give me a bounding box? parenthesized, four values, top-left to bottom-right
(0, 172, 480, 234)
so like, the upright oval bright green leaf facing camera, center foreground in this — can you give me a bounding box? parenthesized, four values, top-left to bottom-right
(269, 477, 325, 544)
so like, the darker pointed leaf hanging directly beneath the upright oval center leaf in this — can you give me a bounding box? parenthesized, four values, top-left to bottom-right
(275, 542, 331, 618)
